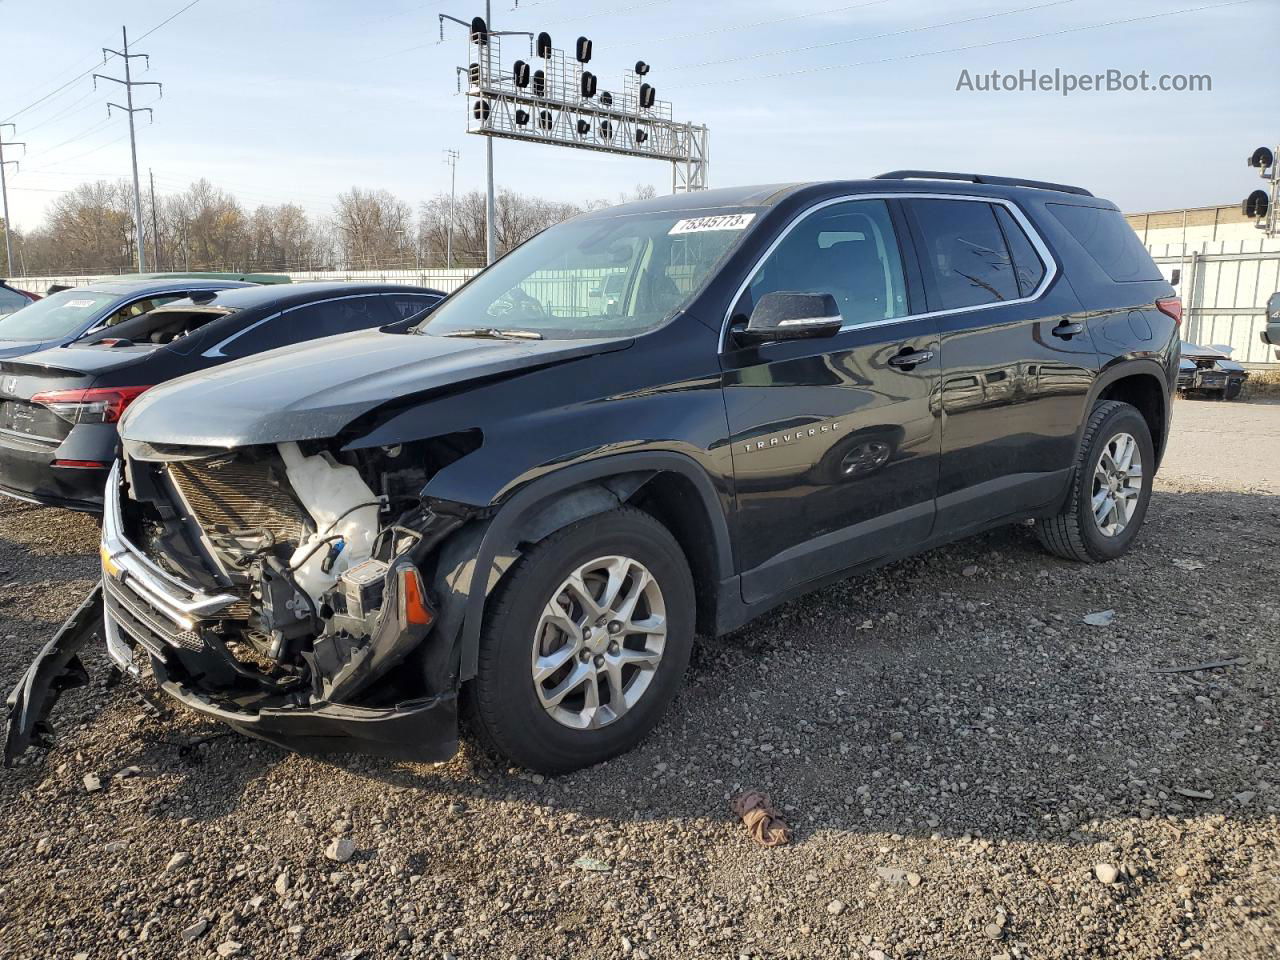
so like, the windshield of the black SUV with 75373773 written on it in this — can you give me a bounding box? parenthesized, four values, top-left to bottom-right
(419, 209, 758, 339)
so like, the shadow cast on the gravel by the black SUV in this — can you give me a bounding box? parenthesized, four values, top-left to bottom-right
(0, 492, 1280, 842)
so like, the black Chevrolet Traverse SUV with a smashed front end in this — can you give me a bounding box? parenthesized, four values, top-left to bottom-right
(8, 172, 1180, 772)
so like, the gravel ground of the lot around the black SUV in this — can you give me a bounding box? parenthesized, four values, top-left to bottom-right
(0, 402, 1280, 960)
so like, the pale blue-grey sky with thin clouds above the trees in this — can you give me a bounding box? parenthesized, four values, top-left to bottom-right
(0, 0, 1280, 227)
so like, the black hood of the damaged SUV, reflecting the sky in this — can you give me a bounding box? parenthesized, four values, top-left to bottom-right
(120, 330, 631, 447)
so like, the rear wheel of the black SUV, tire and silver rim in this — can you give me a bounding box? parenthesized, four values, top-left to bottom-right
(1036, 401, 1156, 563)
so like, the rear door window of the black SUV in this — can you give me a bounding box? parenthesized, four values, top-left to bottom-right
(906, 200, 1021, 310)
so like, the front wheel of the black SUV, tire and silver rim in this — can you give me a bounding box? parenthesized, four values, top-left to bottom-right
(463, 508, 695, 773)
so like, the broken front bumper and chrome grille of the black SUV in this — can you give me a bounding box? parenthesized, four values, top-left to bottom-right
(5, 465, 458, 763)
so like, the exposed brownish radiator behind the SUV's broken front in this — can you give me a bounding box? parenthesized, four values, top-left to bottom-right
(169, 458, 307, 543)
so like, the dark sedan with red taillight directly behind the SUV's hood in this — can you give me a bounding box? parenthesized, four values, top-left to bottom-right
(0, 283, 444, 512)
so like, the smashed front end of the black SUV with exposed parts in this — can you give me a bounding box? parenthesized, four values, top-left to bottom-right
(6, 436, 475, 762)
